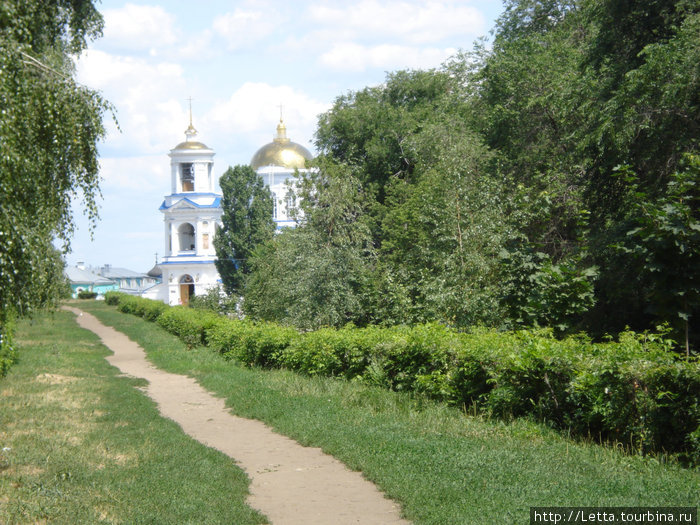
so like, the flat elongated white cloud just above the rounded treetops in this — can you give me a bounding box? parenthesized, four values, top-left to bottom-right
(319, 42, 457, 72)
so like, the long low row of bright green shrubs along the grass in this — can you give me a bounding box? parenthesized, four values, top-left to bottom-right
(107, 296, 700, 463)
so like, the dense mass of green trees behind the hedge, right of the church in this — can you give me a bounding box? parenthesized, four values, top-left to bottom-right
(221, 0, 700, 348)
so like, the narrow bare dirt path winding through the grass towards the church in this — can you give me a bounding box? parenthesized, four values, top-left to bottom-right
(65, 307, 409, 525)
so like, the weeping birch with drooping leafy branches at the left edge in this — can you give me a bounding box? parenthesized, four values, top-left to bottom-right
(0, 0, 109, 368)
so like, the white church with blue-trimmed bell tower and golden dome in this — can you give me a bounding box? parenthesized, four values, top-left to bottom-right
(142, 114, 312, 306)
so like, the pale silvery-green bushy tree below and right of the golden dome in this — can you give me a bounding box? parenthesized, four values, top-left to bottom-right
(243, 159, 374, 329)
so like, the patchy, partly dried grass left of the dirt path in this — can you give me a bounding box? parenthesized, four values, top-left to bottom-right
(0, 312, 265, 524)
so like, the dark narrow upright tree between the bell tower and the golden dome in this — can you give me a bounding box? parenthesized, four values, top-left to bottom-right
(214, 165, 275, 294)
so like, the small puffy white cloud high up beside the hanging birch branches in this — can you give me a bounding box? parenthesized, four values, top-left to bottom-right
(103, 4, 177, 50)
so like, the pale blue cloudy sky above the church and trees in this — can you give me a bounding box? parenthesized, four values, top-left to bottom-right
(66, 0, 502, 272)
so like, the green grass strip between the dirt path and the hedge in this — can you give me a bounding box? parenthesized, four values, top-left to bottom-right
(79, 301, 700, 525)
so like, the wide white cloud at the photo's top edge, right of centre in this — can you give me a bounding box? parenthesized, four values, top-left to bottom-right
(309, 0, 485, 44)
